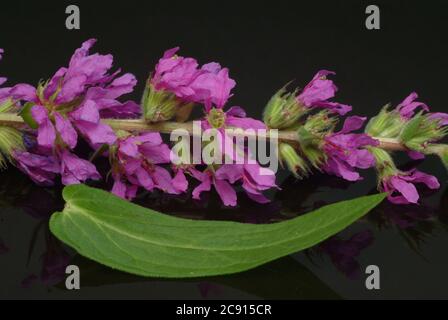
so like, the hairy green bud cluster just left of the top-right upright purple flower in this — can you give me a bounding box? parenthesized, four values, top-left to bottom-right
(263, 88, 307, 129)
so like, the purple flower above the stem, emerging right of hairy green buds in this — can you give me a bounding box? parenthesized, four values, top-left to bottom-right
(297, 70, 352, 115)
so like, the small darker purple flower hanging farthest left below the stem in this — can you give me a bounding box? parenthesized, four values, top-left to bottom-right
(14, 151, 61, 186)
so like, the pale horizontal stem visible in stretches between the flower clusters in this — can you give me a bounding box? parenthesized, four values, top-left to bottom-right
(0, 113, 408, 151)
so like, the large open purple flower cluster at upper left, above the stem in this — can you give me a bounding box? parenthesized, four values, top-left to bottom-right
(11, 39, 139, 149)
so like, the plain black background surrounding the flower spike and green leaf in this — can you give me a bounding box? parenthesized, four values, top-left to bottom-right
(0, 0, 448, 298)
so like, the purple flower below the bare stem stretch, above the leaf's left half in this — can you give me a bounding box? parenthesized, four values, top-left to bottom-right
(112, 133, 180, 199)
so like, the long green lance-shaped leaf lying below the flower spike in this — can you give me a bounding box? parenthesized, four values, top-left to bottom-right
(50, 185, 385, 278)
